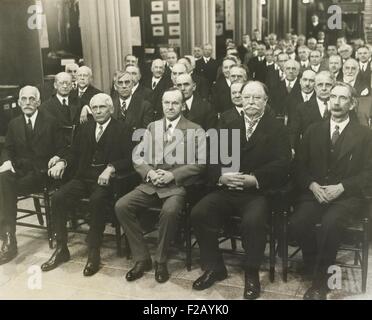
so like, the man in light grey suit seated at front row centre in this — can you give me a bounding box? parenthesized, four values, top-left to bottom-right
(115, 88, 205, 283)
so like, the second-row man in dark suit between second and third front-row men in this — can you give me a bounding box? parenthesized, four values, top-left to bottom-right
(112, 71, 154, 132)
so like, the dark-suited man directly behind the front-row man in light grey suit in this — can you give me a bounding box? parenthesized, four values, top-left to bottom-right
(176, 74, 217, 131)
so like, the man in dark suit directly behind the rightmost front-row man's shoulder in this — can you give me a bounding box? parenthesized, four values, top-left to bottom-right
(289, 71, 335, 153)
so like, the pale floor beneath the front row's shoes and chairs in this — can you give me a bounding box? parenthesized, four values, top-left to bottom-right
(0, 202, 372, 300)
